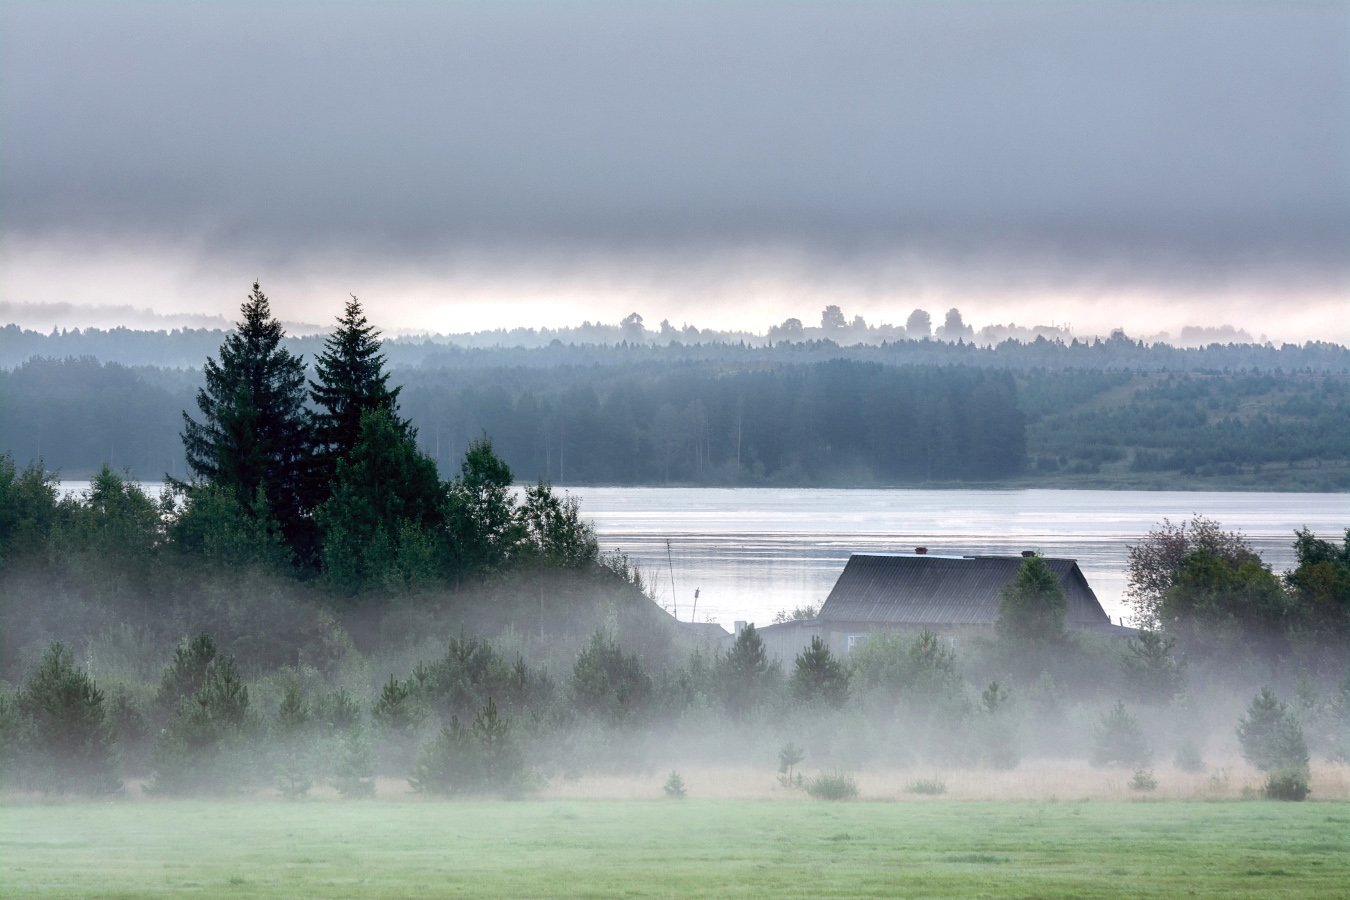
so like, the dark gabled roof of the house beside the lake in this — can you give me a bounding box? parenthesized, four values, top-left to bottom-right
(819, 553, 1111, 627)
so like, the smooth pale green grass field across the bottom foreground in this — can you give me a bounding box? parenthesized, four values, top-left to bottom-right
(0, 799, 1350, 897)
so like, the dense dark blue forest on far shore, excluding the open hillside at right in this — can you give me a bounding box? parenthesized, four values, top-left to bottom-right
(0, 359, 1026, 484)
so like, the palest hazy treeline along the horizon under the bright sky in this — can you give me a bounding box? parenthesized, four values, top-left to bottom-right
(0, 325, 1350, 374)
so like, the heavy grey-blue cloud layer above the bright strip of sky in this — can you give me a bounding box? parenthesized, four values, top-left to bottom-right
(0, 1, 1350, 277)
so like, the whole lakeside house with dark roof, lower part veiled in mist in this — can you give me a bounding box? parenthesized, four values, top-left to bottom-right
(759, 546, 1134, 663)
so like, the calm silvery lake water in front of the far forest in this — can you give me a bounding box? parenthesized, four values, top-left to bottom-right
(62, 482, 1350, 627)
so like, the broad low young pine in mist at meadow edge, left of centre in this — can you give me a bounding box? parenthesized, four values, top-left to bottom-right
(408, 698, 525, 795)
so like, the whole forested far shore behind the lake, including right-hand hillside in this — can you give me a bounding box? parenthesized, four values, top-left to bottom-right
(0, 351, 1350, 490)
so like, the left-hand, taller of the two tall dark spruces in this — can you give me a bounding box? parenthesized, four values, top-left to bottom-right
(182, 282, 313, 559)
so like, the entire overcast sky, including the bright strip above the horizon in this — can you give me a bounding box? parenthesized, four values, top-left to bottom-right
(0, 0, 1350, 341)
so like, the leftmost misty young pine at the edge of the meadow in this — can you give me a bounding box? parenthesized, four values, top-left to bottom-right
(18, 644, 122, 793)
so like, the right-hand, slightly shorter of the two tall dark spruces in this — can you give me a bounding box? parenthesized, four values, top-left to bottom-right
(309, 297, 413, 493)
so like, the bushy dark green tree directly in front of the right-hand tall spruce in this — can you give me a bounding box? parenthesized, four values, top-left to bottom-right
(315, 407, 441, 594)
